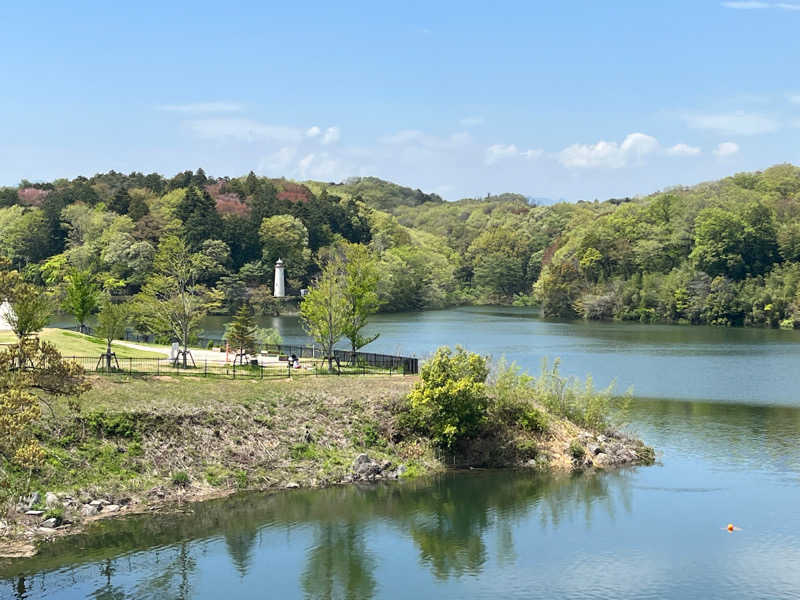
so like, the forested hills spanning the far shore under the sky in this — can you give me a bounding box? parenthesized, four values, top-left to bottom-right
(0, 164, 800, 327)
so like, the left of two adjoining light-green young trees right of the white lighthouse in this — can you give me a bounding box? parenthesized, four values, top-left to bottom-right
(300, 265, 348, 370)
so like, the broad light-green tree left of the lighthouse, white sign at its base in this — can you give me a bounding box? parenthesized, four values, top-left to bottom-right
(136, 236, 221, 368)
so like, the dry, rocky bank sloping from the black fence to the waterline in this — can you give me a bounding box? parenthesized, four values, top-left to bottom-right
(0, 377, 654, 557)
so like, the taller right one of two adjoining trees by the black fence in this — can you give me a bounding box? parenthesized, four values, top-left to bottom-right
(337, 244, 381, 364)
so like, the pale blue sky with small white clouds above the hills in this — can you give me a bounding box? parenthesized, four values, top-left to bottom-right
(0, 0, 800, 201)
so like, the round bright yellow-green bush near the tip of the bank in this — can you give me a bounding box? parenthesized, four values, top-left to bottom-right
(408, 346, 489, 448)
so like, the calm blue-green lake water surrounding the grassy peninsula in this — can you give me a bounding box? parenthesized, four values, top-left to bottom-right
(0, 308, 800, 599)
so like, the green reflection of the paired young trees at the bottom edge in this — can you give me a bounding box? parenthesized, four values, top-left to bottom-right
(300, 522, 375, 600)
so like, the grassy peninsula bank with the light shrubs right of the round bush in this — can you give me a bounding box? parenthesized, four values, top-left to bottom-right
(0, 364, 652, 549)
